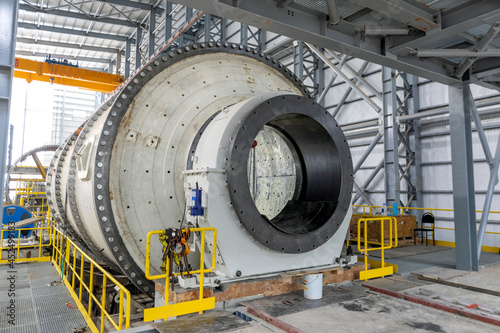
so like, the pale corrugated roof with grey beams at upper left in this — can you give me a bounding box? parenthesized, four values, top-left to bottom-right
(16, 0, 164, 70)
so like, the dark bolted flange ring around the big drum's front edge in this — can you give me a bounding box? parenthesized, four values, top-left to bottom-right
(94, 42, 309, 295)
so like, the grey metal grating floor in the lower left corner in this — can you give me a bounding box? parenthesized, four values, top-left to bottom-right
(0, 262, 87, 333)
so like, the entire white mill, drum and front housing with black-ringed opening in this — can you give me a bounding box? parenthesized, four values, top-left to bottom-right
(47, 43, 353, 295)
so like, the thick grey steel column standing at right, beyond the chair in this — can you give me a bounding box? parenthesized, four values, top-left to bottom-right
(448, 83, 478, 271)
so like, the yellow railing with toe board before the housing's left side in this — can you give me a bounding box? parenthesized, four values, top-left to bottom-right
(144, 228, 217, 321)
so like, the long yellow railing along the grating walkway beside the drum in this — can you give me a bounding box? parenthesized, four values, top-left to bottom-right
(52, 227, 131, 333)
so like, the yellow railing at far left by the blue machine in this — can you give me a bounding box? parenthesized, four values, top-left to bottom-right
(0, 212, 53, 265)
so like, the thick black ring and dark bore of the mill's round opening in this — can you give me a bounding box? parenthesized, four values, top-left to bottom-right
(227, 95, 353, 253)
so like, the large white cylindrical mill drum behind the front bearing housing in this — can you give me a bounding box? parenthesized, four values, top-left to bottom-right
(47, 43, 352, 294)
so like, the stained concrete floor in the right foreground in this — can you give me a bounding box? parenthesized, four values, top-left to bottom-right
(134, 245, 500, 333)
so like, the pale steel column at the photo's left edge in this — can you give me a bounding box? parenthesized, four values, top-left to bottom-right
(0, 0, 19, 225)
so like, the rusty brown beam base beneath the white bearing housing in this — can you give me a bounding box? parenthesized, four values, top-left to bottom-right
(156, 264, 364, 303)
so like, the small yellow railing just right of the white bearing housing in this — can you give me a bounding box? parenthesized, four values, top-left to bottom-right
(357, 216, 398, 281)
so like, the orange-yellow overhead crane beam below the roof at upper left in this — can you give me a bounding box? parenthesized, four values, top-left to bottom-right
(14, 58, 124, 93)
